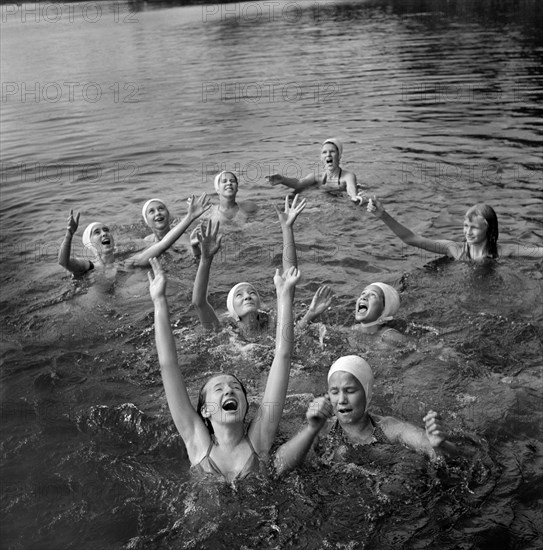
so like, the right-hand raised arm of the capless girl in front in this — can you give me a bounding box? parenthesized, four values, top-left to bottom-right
(249, 267, 300, 453)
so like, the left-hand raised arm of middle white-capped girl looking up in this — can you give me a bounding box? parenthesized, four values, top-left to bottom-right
(192, 220, 222, 329)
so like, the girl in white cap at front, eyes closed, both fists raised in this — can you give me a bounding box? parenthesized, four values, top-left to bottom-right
(275, 355, 458, 473)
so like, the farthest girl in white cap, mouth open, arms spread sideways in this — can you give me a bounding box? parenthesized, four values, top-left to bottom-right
(266, 138, 364, 204)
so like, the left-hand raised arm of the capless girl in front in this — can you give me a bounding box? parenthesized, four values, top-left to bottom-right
(148, 258, 210, 463)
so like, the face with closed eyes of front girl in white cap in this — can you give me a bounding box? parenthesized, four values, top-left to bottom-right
(328, 370, 366, 424)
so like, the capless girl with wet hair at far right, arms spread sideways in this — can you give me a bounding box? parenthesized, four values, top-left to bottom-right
(368, 196, 543, 261)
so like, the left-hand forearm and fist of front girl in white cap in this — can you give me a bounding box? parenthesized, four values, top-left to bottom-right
(274, 397, 333, 474)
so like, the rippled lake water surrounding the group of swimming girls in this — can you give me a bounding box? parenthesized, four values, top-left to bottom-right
(0, 0, 543, 550)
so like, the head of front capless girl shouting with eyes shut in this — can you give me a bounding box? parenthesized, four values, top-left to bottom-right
(196, 373, 249, 435)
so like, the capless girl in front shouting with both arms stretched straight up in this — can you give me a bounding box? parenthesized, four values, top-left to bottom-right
(149, 258, 300, 483)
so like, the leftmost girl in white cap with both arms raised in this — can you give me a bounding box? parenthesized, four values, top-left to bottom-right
(58, 193, 211, 275)
